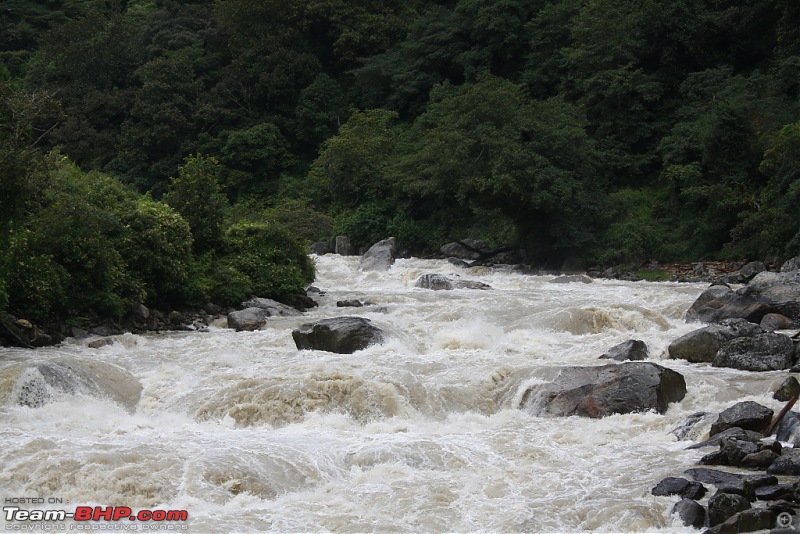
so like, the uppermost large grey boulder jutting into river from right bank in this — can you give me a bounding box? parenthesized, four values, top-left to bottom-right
(686, 284, 775, 323)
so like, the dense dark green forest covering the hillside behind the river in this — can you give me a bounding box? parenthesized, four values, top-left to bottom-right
(0, 0, 800, 330)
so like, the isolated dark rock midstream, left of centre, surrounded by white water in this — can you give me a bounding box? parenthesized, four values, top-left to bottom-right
(292, 317, 384, 354)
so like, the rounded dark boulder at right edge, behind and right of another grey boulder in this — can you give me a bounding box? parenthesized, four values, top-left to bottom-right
(711, 332, 794, 371)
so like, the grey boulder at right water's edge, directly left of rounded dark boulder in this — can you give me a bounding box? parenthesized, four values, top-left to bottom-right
(667, 319, 764, 363)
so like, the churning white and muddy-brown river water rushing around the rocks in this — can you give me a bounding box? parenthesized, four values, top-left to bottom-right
(0, 255, 785, 533)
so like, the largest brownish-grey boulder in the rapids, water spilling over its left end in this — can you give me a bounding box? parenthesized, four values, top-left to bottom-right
(520, 362, 686, 418)
